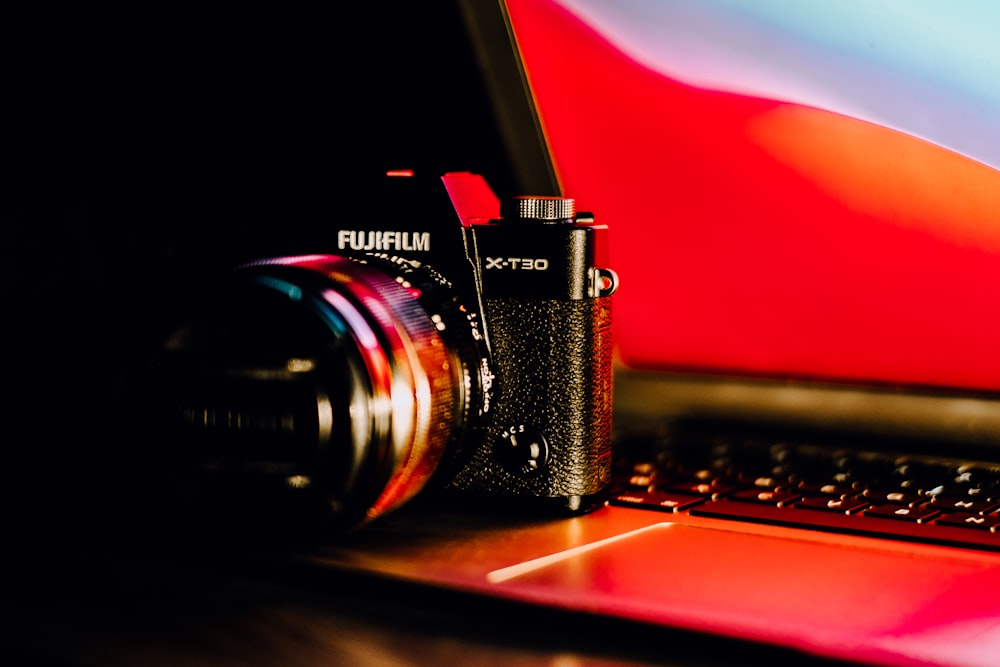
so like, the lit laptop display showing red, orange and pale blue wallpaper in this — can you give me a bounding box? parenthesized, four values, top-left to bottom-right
(508, 0, 1000, 391)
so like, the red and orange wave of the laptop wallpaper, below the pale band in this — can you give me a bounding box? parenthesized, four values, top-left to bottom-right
(509, 0, 1000, 390)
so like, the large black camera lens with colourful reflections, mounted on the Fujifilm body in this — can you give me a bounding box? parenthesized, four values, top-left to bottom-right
(150, 255, 490, 528)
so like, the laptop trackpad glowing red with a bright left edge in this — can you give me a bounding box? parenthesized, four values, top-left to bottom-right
(480, 523, 1000, 664)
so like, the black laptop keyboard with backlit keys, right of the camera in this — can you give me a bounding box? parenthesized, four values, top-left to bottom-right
(609, 437, 1000, 551)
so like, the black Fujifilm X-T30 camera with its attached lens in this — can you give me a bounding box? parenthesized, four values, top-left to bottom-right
(151, 171, 618, 530)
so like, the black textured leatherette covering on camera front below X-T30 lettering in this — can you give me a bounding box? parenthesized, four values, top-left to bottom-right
(451, 298, 612, 497)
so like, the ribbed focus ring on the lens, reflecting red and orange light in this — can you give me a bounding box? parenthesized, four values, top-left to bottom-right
(258, 256, 458, 521)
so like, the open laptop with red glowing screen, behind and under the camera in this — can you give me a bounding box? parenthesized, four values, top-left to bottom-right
(292, 0, 1000, 665)
